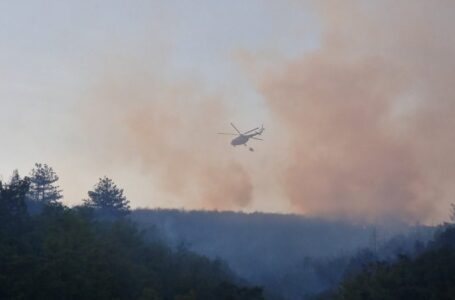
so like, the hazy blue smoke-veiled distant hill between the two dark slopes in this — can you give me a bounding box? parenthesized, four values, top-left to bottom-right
(132, 209, 431, 299)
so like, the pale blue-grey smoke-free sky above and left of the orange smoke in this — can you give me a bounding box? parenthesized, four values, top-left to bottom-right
(0, 1, 318, 210)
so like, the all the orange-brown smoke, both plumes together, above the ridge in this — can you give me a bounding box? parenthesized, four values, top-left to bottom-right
(78, 0, 455, 221)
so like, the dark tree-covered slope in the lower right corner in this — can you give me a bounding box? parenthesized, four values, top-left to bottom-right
(320, 226, 455, 300)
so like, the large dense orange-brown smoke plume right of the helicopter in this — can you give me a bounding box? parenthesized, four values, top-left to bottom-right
(259, 0, 455, 221)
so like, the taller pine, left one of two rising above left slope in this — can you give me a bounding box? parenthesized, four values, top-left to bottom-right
(28, 163, 63, 204)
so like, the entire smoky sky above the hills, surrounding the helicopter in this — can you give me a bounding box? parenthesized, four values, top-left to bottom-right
(0, 0, 455, 221)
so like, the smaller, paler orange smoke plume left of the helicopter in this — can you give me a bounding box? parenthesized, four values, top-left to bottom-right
(81, 64, 253, 209)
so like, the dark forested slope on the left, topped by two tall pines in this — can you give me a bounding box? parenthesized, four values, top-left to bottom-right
(0, 173, 263, 300)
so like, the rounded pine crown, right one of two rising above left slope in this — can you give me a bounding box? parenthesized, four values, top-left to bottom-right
(84, 177, 130, 216)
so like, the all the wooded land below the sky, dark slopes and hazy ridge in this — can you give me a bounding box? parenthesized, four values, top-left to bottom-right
(0, 164, 448, 300)
